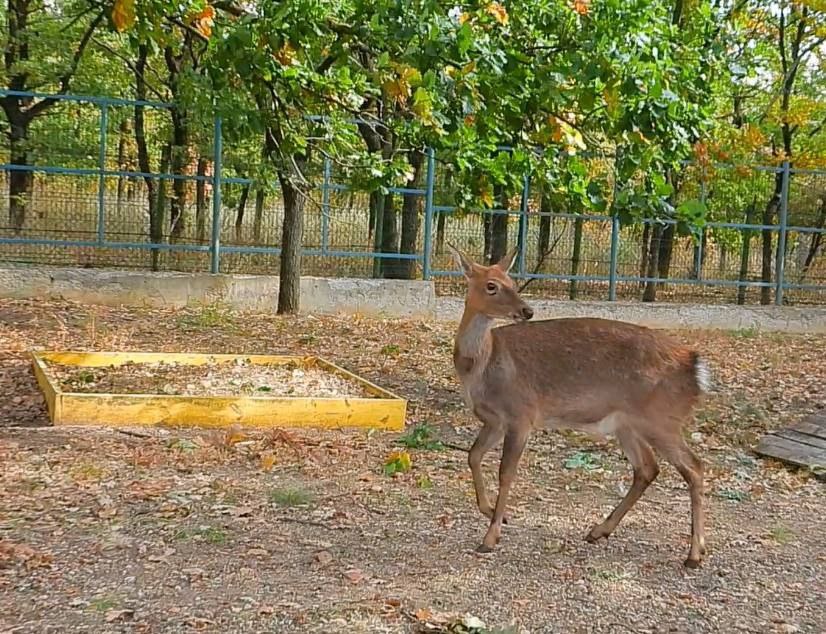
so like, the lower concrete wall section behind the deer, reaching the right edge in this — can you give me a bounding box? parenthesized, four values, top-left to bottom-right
(436, 297, 826, 334)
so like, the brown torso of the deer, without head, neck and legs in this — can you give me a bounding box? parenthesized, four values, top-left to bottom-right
(485, 318, 698, 428)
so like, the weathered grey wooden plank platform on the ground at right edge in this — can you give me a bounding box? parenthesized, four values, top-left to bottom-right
(757, 412, 826, 480)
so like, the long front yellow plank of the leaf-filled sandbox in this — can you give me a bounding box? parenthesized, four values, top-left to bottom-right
(55, 394, 407, 430)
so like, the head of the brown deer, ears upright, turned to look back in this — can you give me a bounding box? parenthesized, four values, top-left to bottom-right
(448, 244, 533, 321)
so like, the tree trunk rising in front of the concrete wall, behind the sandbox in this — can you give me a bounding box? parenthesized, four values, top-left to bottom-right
(278, 170, 305, 315)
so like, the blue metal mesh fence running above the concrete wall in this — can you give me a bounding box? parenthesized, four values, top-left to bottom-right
(0, 90, 826, 304)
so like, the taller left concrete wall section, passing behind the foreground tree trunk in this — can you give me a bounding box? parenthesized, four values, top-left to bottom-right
(0, 267, 436, 318)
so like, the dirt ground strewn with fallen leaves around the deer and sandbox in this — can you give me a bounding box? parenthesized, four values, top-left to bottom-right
(0, 301, 826, 634)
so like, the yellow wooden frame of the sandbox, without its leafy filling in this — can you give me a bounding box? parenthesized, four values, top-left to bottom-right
(31, 351, 407, 430)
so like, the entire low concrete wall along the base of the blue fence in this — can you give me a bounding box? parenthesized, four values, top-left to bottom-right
(0, 267, 826, 333)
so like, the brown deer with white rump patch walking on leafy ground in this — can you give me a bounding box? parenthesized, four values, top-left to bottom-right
(448, 245, 710, 568)
